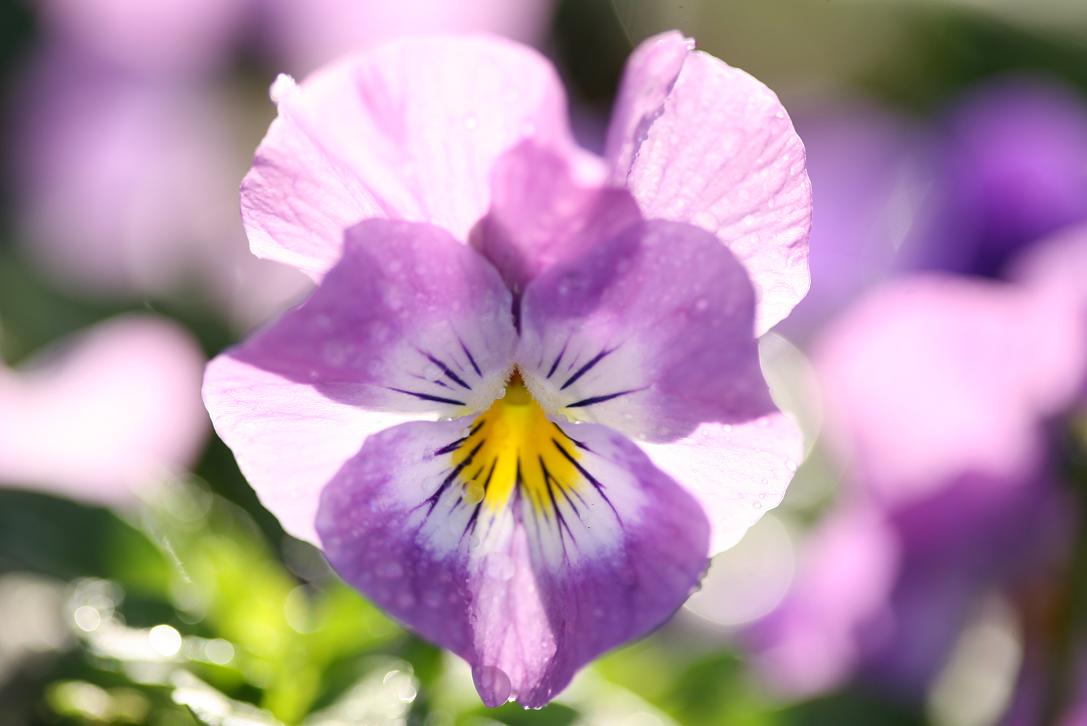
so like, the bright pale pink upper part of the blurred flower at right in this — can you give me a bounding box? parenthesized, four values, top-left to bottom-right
(814, 275, 1087, 503)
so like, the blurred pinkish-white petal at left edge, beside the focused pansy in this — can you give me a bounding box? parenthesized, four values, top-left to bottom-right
(0, 316, 208, 504)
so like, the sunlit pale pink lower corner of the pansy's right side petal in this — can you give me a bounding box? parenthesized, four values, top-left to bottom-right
(638, 412, 803, 556)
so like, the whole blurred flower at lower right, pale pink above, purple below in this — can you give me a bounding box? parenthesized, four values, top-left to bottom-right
(752, 242, 1087, 694)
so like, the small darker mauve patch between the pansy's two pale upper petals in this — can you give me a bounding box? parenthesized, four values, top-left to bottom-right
(472, 142, 641, 291)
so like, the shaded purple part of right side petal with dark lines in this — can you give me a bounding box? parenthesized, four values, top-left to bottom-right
(517, 222, 773, 441)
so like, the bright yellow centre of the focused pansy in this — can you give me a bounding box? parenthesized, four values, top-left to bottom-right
(452, 370, 583, 512)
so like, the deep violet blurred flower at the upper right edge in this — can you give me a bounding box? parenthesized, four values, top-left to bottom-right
(914, 78, 1087, 276)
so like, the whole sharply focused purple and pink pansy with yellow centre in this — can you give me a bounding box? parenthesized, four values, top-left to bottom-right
(204, 34, 810, 706)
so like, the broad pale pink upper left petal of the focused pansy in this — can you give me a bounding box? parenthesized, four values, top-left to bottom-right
(241, 36, 573, 278)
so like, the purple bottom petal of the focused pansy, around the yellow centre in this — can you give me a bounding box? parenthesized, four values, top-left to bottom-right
(317, 420, 708, 708)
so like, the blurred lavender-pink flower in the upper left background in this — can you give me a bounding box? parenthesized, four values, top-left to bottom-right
(14, 55, 307, 328)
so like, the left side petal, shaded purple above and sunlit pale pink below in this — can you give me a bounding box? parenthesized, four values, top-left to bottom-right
(204, 220, 516, 540)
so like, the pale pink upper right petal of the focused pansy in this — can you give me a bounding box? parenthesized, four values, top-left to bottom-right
(608, 34, 811, 334)
